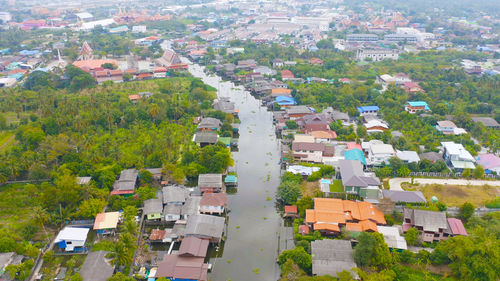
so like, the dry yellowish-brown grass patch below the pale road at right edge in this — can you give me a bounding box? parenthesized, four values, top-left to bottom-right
(408, 184, 500, 206)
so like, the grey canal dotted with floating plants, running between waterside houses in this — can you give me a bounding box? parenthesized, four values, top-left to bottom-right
(189, 60, 281, 281)
